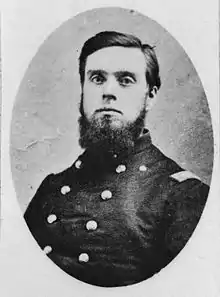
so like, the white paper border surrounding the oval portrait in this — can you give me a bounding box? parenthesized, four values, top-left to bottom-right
(0, 0, 220, 297)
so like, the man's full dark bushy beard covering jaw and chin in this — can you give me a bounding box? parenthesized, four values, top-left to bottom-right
(78, 96, 146, 154)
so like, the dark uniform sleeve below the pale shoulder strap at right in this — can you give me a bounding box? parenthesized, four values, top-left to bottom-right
(165, 177, 209, 258)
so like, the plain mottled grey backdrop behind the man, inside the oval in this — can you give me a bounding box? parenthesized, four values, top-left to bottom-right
(11, 8, 213, 211)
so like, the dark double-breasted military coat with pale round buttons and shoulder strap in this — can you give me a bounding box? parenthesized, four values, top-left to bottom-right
(24, 132, 209, 287)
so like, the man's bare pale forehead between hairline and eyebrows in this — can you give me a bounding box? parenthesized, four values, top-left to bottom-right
(86, 46, 146, 74)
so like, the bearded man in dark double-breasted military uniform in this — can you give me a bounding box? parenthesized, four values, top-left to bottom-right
(24, 31, 209, 287)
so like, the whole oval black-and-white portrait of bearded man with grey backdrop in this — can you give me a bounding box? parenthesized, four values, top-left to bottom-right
(11, 8, 213, 287)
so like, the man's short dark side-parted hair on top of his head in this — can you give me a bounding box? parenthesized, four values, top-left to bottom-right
(79, 31, 161, 90)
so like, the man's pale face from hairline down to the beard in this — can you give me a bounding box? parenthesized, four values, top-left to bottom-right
(83, 46, 149, 128)
